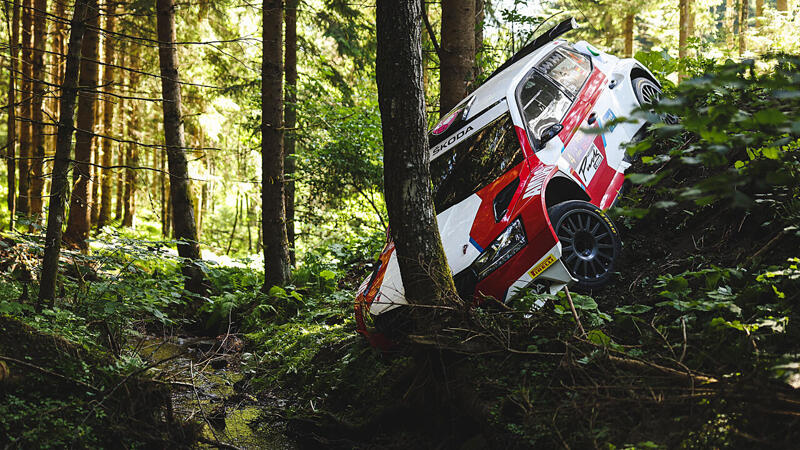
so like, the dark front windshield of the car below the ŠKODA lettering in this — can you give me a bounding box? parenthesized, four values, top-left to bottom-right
(431, 113, 524, 212)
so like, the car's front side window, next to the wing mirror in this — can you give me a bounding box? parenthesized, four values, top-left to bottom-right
(517, 69, 572, 141)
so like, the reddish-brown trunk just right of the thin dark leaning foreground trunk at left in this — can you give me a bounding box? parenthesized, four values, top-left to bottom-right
(64, 0, 100, 250)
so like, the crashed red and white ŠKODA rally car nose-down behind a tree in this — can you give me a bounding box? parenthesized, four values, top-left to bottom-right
(355, 19, 661, 337)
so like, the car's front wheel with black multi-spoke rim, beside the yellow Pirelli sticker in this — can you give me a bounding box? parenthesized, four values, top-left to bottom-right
(548, 200, 622, 290)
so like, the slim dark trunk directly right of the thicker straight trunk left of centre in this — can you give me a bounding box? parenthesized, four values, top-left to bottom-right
(283, 0, 298, 266)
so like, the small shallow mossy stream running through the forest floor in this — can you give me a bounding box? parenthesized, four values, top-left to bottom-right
(134, 335, 297, 450)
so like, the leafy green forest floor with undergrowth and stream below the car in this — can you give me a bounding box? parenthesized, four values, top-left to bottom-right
(0, 161, 800, 448)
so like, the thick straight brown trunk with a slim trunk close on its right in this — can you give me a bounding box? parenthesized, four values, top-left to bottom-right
(261, 0, 290, 289)
